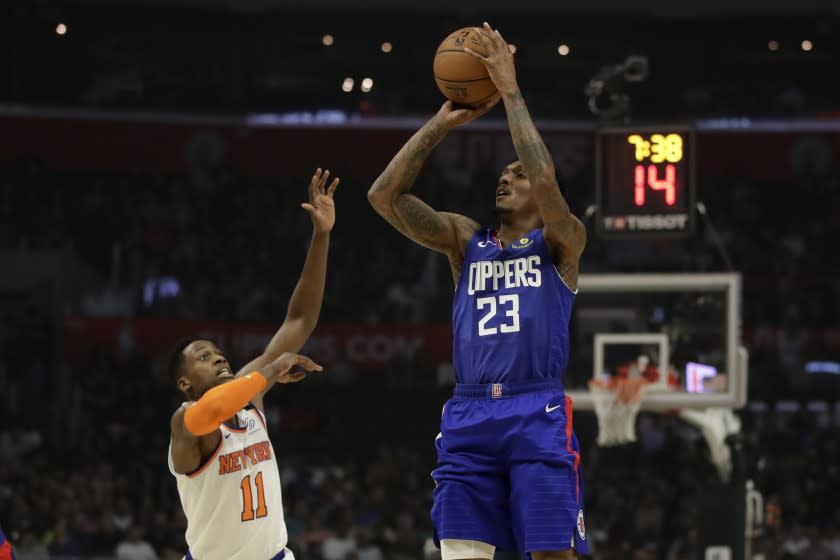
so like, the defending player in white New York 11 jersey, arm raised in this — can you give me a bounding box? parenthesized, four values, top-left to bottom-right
(169, 169, 339, 560)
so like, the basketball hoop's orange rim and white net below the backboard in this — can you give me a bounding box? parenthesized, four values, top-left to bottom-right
(589, 377, 648, 447)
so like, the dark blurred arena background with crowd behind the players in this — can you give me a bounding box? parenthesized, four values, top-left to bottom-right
(0, 0, 840, 560)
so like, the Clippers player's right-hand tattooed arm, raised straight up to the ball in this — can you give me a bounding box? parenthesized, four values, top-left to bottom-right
(464, 22, 586, 289)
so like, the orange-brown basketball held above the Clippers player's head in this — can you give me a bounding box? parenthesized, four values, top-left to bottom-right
(434, 27, 496, 106)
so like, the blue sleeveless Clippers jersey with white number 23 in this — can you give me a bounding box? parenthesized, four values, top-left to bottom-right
(452, 228, 575, 384)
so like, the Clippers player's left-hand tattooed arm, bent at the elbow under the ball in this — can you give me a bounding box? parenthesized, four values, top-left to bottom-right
(368, 97, 499, 259)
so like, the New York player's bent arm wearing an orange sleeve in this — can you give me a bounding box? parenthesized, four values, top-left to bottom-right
(170, 352, 323, 474)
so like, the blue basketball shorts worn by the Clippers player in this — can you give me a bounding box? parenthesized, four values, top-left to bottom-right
(432, 380, 589, 554)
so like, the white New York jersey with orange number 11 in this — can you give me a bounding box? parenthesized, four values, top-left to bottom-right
(169, 408, 293, 560)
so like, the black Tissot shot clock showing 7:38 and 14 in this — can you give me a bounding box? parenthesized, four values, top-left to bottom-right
(595, 126, 694, 237)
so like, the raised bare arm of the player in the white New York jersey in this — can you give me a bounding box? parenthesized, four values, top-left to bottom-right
(236, 167, 339, 410)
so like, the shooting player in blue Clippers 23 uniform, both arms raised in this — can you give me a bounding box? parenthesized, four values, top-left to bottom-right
(368, 23, 588, 560)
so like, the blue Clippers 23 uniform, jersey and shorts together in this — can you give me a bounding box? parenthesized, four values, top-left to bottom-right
(432, 229, 588, 553)
